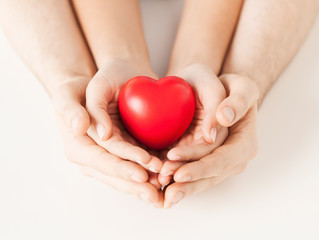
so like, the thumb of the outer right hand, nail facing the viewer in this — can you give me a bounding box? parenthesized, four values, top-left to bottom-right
(216, 74, 259, 127)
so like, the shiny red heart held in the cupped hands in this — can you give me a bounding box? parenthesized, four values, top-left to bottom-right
(119, 76, 195, 150)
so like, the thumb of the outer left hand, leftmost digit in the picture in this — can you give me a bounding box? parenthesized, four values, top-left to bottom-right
(52, 77, 90, 135)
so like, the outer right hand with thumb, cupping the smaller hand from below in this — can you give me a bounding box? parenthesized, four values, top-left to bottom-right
(164, 74, 259, 208)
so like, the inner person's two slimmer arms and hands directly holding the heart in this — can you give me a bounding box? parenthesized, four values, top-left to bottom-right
(73, 0, 242, 208)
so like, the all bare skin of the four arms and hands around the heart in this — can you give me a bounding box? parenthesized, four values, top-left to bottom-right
(0, 0, 319, 208)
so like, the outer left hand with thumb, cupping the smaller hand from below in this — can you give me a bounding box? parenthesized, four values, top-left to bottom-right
(51, 77, 163, 206)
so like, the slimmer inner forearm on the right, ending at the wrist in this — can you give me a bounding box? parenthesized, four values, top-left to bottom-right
(169, 0, 243, 74)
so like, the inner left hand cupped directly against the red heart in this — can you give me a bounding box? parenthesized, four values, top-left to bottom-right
(86, 59, 162, 173)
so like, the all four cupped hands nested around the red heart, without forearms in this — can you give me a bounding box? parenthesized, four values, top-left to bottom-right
(52, 59, 258, 208)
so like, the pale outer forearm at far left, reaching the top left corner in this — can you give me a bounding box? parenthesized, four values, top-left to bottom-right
(0, 0, 95, 93)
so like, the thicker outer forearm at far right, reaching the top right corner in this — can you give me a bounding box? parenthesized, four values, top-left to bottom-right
(223, 0, 319, 105)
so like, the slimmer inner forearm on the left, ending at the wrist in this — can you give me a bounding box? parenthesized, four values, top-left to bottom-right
(73, 0, 150, 68)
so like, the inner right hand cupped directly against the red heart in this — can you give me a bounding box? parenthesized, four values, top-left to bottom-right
(159, 64, 228, 185)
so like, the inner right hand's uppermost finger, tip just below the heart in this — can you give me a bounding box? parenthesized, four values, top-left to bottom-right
(167, 127, 228, 161)
